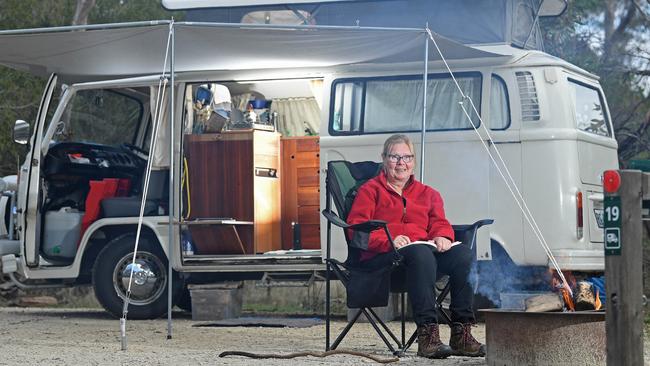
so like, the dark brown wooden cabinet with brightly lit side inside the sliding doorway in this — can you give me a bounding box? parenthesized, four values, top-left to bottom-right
(183, 130, 281, 254)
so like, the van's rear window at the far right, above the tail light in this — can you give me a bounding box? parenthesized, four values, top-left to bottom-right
(569, 79, 612, 136)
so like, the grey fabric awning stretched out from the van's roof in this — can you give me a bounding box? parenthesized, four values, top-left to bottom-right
(0, 21, 502, 81)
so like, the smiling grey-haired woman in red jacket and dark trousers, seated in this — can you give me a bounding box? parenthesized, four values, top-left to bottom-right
(348, 135, 485, 358)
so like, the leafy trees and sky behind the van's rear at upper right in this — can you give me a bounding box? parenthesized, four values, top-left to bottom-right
(542, 0, 650, 166)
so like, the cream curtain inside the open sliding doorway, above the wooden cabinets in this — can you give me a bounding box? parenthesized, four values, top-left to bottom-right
(271, 98, 320, 136)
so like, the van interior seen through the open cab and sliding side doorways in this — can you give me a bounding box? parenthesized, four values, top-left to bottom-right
(40, 79, 323, 265)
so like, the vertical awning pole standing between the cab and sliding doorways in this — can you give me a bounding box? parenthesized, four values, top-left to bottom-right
(167, 18, 176, 339)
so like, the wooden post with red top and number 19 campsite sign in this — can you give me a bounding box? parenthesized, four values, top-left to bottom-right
(604, 170, 650, 366)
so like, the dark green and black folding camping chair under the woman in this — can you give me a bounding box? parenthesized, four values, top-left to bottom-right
(323, 160, 492, 355)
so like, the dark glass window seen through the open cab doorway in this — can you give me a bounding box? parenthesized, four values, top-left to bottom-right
(52, 89, 144, 145)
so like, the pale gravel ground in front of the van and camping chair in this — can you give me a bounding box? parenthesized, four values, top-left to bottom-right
(0, 308, 486, 366)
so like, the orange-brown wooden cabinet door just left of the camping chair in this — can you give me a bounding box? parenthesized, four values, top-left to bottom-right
(281, 136, 320, 249)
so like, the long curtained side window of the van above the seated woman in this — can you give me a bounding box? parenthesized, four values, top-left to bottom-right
(330, 73, 481, 135)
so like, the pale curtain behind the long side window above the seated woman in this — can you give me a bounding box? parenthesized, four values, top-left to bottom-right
(363, 76, 481, 133)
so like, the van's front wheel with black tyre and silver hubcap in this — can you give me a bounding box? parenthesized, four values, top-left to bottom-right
(93, 233, 182, 319)
